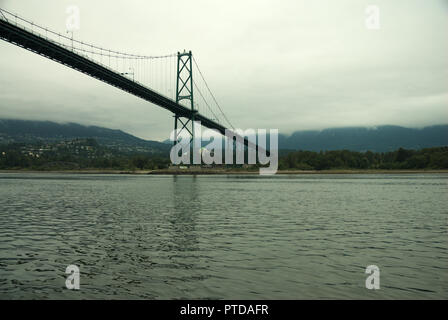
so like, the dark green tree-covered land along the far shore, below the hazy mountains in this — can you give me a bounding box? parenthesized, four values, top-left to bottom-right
(0, 139, 448, 170)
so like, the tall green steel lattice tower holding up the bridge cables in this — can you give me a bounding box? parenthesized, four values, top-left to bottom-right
(174, 50, 197, 145)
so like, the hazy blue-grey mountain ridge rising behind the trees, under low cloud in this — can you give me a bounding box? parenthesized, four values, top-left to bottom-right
(0, 119, 448, 153)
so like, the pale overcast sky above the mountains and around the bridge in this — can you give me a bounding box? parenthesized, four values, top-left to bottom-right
(0, 0, 448, 140)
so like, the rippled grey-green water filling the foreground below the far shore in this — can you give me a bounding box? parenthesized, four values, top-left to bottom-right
(0, 174, 448, 299)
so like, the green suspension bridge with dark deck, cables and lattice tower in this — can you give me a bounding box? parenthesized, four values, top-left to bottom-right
(0, 8, 257, 148)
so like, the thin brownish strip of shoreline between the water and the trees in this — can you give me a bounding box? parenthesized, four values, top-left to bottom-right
(0, 169, 448, 175)
